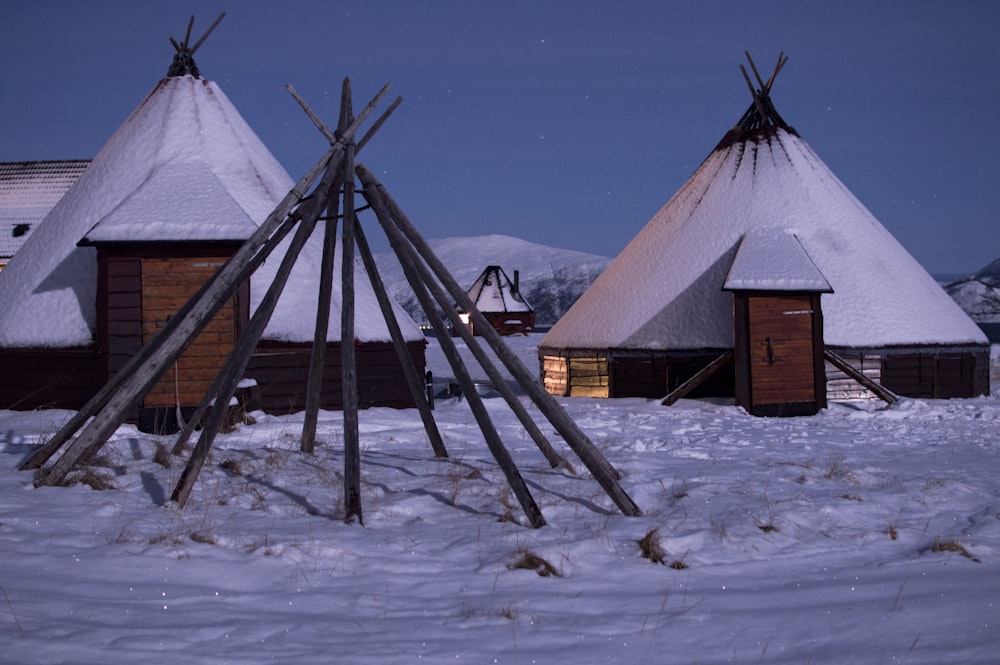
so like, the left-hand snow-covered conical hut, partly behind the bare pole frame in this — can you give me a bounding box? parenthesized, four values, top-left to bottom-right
(0, 55, 426, 431)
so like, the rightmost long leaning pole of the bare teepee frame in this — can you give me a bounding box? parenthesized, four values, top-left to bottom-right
(357, 164, 642, 516)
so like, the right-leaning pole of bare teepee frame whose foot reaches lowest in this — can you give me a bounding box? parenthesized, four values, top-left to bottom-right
(359, 175, 545, 528)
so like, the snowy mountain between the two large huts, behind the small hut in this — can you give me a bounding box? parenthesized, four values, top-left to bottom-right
(376, 235, 611, 326)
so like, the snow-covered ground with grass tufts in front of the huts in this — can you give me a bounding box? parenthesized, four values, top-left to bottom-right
(0, 335, 1000, 665)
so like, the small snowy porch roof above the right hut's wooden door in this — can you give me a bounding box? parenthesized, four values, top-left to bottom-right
(723, 227, 833, 293)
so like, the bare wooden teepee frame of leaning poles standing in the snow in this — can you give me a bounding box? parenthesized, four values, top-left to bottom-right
(21, 75, 641, 527)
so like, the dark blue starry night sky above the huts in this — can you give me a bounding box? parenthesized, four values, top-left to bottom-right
(0, 0, 1000, 274)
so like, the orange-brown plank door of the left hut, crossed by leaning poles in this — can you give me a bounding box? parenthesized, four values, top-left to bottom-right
(140, 256, 239, 432)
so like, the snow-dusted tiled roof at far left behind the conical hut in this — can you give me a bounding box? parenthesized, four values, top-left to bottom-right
(0, 159, 90, 262)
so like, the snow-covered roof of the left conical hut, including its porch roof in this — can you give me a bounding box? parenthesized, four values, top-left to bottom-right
(0, 76, 422, 347)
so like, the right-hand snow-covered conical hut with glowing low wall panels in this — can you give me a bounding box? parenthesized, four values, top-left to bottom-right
(539, 58, 989, 406)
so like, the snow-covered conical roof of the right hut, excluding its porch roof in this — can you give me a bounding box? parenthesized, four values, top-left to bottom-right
(542, 128, 987, 349)
